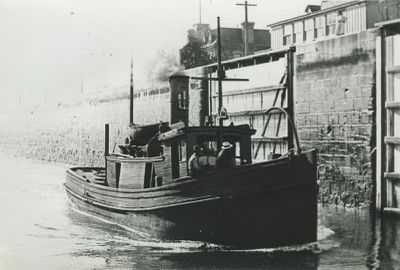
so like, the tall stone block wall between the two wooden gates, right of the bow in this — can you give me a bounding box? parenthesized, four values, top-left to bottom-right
(295, 30, 377, 206)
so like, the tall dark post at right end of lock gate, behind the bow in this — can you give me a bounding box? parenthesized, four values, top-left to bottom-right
(286, 47, 295, 150)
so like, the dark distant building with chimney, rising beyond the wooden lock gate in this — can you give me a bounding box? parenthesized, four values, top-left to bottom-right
(188, 22, 271, 60)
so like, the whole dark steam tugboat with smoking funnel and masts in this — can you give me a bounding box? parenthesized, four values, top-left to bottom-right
(65, 17, 318, 248)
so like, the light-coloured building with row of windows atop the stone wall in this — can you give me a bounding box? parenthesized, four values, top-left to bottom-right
(268, 0, 385, 49)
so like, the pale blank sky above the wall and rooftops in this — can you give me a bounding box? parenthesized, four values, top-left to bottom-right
(0, 0, 320, 112)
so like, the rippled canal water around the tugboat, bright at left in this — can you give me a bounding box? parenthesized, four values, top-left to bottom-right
(0, 156, 400, 269)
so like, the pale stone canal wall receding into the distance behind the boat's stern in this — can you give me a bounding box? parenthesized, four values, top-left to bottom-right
(0, 87, 170, 166)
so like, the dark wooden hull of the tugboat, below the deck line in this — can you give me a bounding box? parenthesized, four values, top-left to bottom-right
(66, 152, 318, 248)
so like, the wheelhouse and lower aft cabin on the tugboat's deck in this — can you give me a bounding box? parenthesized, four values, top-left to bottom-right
(106, 125, 255, 189)
